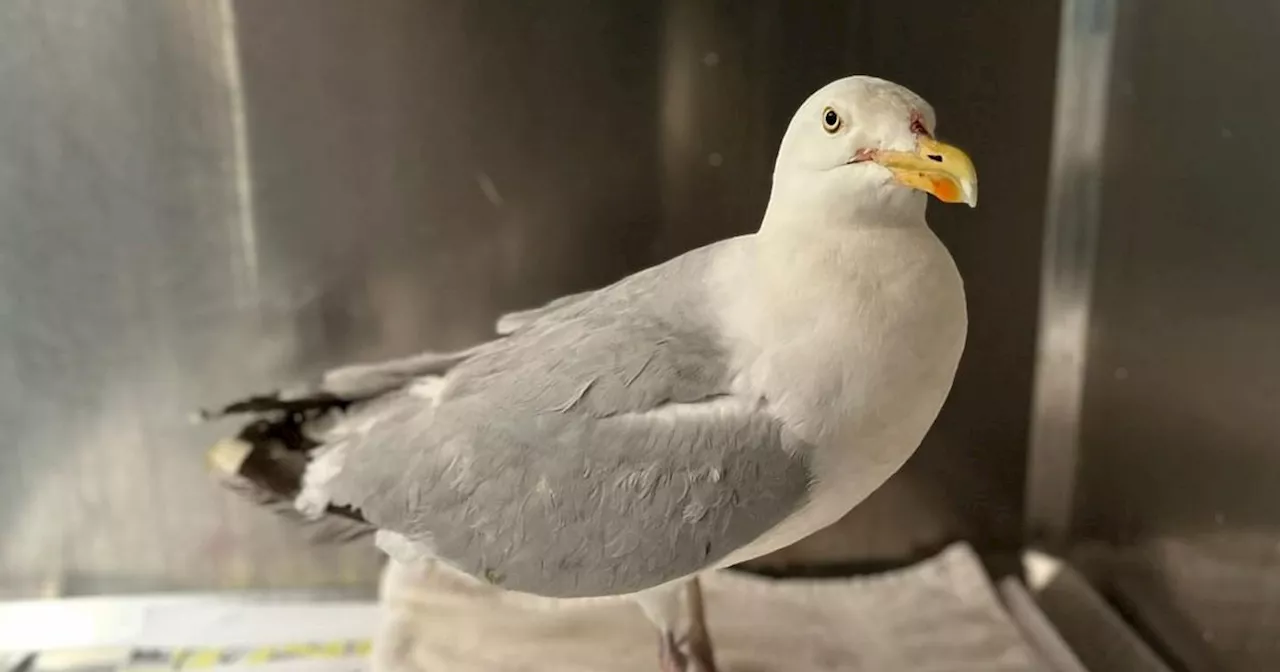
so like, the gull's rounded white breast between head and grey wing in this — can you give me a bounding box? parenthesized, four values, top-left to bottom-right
(723, 227, 968, 566)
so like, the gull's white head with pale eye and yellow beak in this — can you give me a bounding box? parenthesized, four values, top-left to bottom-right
(773, 77, 978, 220)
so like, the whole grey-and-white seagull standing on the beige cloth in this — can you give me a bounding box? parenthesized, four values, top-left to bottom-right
(206, 76, 978, 672)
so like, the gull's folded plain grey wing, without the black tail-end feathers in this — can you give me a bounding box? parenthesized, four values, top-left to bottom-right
(316, 241, 810, 596)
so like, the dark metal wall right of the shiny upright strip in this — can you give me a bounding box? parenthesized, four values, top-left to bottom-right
(1032, 0, 1280, 671)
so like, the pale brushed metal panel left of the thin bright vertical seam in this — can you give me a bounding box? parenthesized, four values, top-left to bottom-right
(0, 0, 394, 594)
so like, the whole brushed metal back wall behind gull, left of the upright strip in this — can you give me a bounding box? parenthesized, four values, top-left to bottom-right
(0, 0, 1057, 594)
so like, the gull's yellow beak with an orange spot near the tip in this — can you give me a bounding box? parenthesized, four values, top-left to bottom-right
(873, 137, 978, 207)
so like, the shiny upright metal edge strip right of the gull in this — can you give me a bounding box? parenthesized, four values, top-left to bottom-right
(1025, 0, 1116, 547)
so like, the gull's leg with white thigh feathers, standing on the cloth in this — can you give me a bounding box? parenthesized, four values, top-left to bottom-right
(639, 579, 716, 672)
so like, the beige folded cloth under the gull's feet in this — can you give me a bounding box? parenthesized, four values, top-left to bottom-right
(372, 545, 1042, 672)
